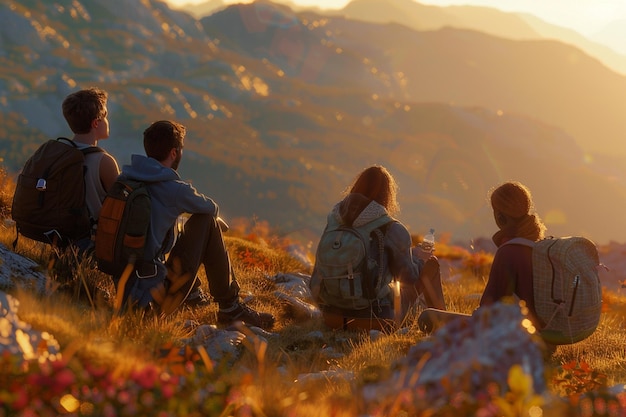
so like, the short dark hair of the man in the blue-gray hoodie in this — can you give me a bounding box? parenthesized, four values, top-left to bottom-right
(143, 120, 187, 161)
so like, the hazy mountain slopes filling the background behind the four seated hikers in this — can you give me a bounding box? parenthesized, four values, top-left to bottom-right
(0, 0, 626, 244)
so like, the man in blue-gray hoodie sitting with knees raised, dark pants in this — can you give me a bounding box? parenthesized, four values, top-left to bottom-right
(116, 120, 274, 329)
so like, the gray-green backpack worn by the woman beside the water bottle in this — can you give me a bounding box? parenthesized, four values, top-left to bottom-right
(311, 213, 393, 310)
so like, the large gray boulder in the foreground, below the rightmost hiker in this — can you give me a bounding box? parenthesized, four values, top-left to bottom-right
(361, 303, 546, 412)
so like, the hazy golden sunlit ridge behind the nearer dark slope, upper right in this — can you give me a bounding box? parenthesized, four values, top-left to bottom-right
(201, 4, 626, 155)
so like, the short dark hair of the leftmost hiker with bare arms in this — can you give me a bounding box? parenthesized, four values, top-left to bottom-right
(61, 87, 108, 134)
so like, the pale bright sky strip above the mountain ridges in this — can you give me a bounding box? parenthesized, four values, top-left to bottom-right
(166, 0, 626, 35)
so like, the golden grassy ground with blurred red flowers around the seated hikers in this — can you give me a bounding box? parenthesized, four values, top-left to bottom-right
(0, 200, 626, 417)
